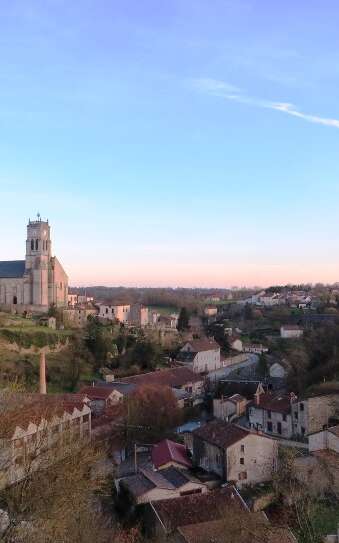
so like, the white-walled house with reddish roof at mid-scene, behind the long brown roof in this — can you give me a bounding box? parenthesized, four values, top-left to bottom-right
(177, 338, 221, 373)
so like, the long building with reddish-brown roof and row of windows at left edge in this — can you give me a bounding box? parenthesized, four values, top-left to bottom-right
(0, 394, 91, 489)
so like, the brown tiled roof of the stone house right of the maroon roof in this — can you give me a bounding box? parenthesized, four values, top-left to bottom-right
(192, 420, 251, 449)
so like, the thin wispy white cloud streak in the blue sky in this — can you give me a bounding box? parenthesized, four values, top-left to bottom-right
(192, 78, 339, 128)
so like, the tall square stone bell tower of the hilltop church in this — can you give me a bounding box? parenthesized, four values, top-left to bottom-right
(24, 213, 51, 307)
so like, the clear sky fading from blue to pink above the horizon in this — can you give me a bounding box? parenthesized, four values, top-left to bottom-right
(0, 0, 339, 287)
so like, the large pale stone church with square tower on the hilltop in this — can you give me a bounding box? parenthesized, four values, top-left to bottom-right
(0, 214, 68, 312)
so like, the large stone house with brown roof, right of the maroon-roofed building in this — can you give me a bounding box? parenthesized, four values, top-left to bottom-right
(192, 420, 278, 487)
